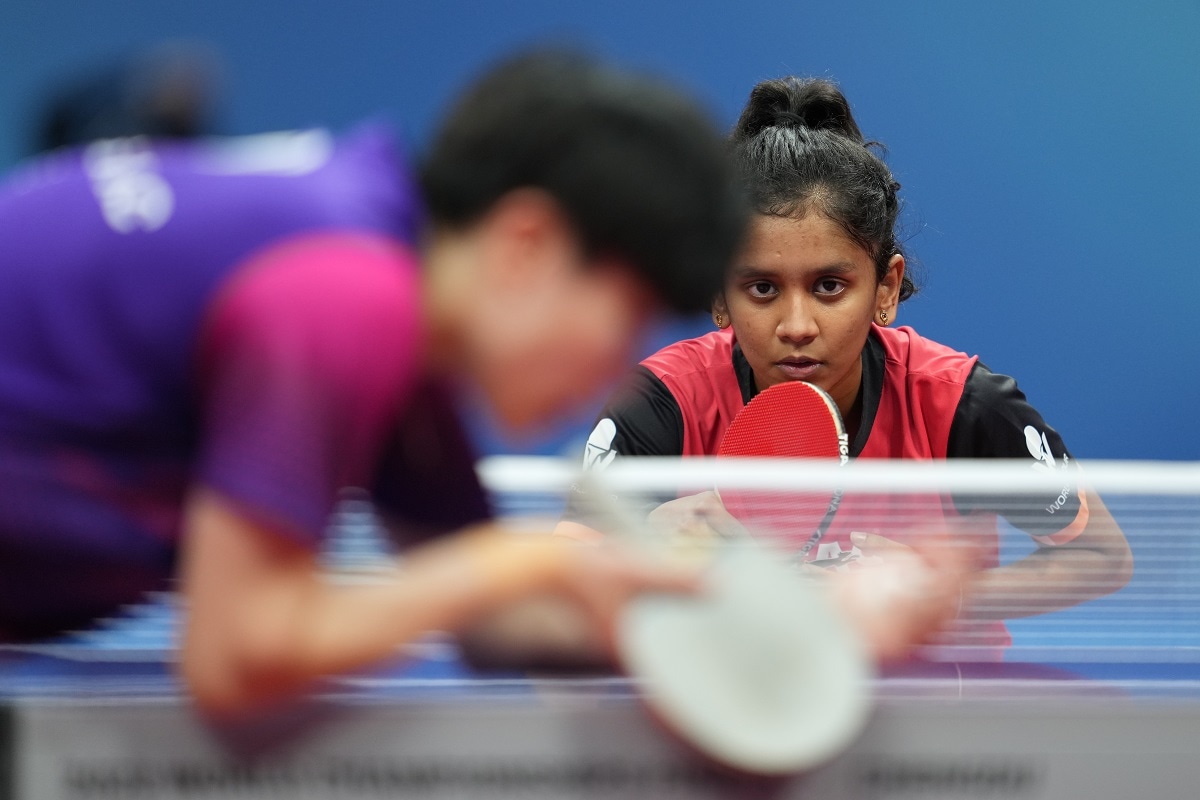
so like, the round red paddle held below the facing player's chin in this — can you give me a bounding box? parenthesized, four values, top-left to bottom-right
(716, 381, 850, 561)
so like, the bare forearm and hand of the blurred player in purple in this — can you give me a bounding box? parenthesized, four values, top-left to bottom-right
(181, 489, 701, 715)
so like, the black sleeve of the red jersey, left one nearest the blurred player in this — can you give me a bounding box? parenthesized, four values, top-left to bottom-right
(564, 367, 683, 530)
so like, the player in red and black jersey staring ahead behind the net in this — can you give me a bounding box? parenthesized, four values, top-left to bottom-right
(559, 77, 1132, 648)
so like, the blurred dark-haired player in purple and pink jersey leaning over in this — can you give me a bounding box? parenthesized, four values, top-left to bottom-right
(0, 53, 746, 714)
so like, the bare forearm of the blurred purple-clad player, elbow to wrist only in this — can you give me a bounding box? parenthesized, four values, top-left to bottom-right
(182, 495, 566, 714)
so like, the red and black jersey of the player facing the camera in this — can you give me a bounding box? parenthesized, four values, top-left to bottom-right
(584, 326, 1087, 646)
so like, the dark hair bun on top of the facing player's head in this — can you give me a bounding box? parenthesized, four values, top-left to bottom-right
(734, 77, 864, 143)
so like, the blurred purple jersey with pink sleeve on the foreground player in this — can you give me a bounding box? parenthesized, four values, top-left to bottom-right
(0, 130, 484, 639)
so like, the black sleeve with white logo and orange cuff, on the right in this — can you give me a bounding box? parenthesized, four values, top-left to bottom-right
(947, 363, 1087, 543)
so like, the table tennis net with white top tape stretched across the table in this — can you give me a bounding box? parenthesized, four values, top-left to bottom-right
(19, 457, 1200, 663)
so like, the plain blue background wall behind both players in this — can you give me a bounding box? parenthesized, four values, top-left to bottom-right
(0, 0, 1200, 459)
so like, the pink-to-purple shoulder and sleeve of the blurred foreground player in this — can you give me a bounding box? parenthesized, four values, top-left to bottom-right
(194, 234, 422, 537)
